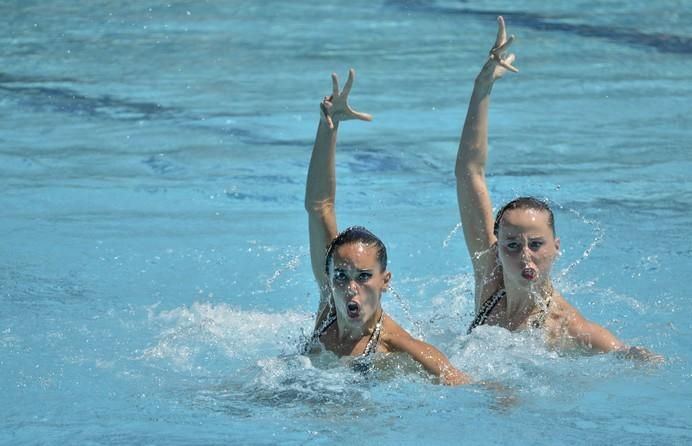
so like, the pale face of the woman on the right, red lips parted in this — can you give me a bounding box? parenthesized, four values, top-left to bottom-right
(497, 209, 560, 286)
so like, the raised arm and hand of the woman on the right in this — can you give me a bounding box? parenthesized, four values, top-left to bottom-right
(455, 17, 518, 288)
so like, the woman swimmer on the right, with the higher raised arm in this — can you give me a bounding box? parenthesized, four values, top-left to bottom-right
(455, 17, 663, 361)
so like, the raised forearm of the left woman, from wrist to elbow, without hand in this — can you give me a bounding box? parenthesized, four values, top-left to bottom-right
(305, 120, 339, 214)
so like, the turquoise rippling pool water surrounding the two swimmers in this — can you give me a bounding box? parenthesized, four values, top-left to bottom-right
(0, 0, 692, 445)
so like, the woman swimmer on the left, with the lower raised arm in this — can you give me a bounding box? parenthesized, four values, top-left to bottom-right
(303, 69, 471, 385)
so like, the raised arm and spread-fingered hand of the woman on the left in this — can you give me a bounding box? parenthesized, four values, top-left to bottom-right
(305, 69, 372, 316)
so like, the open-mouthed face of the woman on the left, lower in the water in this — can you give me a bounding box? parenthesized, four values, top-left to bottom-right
(329, 242, 391, 324)
